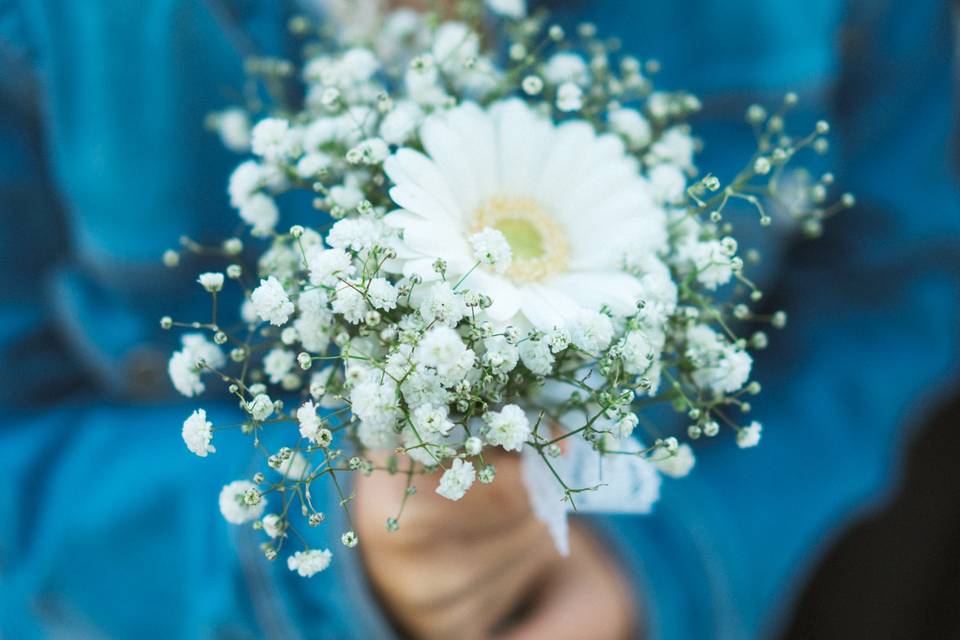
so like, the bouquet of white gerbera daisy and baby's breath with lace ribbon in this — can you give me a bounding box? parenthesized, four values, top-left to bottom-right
(161, 0, 853, 576)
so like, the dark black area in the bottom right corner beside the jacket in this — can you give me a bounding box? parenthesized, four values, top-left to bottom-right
(783, 395, 960, 640)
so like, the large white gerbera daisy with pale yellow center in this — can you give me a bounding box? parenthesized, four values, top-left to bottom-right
(385, 99, 667, 331)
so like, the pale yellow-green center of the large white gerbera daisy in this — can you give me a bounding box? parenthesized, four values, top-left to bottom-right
(471, 196, 569, 282)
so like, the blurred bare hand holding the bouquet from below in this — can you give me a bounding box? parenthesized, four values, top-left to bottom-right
(352, 452, 638, 640)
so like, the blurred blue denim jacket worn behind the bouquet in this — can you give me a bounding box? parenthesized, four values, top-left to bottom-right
(0, 0, 960, 638)
